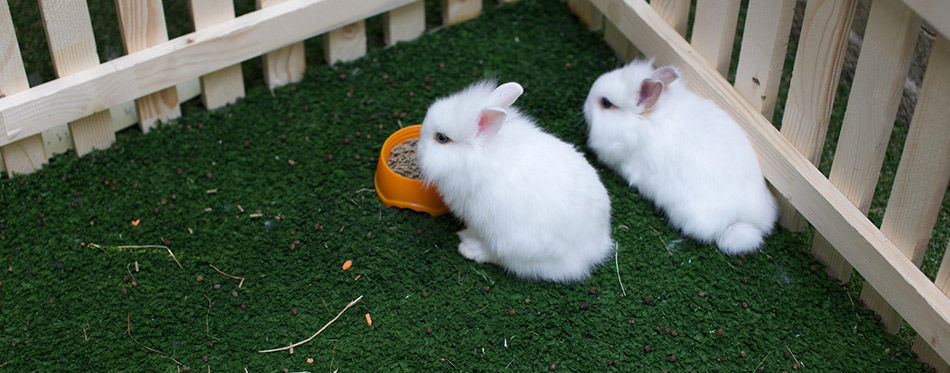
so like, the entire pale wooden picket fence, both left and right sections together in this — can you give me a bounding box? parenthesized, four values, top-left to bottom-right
(0, 0, 950, 371)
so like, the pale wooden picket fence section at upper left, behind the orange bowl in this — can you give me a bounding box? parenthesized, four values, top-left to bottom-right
(0, 0, 482, 176)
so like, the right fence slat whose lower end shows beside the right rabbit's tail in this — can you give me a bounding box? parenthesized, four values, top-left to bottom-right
(779, 0, 858, 232)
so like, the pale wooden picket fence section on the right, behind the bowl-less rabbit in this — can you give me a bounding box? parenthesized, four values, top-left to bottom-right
(570, 0, 950, 371)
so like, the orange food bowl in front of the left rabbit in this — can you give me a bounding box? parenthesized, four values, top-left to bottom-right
(375, 124, 449, 216)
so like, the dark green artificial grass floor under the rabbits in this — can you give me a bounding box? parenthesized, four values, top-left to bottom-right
(0, 0, 936, 372)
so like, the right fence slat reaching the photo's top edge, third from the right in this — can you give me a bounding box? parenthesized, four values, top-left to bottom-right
(735, 0, 795, 120)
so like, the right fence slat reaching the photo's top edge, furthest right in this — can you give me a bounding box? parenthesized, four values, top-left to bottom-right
(811, 0, 920, 281)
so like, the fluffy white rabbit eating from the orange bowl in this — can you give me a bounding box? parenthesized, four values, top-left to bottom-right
(416, 81, 614, 282)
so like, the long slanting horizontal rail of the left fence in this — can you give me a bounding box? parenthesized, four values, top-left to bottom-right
(0, 0, 411, 146)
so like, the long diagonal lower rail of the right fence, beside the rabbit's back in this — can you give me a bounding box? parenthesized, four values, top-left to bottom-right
(593, 0, 950, 359)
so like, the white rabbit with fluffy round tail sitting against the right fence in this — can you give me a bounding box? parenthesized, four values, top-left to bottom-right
(584, 60, 778, 255)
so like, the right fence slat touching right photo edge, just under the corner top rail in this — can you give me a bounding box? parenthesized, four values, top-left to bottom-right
(861, 37, 950, 333)
